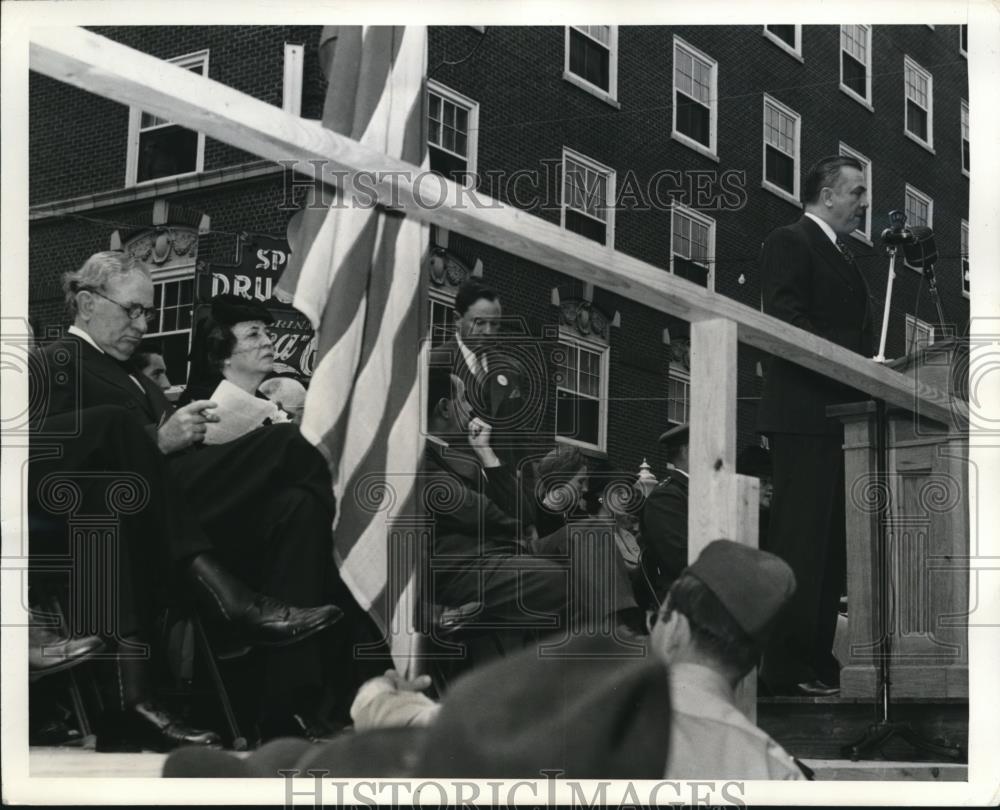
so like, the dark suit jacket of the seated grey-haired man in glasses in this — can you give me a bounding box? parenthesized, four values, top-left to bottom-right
(35, 335, 174, 439)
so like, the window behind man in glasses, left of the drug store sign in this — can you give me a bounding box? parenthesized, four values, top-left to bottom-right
(143, 266, 194, 385)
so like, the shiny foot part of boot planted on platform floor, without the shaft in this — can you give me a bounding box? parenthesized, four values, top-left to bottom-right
(97, 701, 221, 753)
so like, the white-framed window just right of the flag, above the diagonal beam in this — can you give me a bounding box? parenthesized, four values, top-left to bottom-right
(427, 79, 479, 185)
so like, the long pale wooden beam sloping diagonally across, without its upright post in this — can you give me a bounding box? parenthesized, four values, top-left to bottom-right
(30, 27, 955, 425)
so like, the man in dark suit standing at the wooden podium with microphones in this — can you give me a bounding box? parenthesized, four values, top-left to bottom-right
(758, 156, 873, 696)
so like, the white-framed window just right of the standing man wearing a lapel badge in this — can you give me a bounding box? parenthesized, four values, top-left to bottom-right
(555, 331, 610, 451)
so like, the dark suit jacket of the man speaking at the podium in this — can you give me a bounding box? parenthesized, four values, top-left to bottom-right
(758, 217, 873, 434)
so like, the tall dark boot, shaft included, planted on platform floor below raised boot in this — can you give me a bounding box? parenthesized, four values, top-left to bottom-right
(96, 653, 221, 752)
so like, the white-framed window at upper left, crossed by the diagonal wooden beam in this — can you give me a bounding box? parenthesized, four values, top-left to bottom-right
(125, 50, 208, 186)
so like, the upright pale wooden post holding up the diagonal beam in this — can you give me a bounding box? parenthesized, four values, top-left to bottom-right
(688, 318, 759, 722)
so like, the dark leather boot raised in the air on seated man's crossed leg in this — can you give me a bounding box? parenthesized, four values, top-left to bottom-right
(187, 554, 344, 647)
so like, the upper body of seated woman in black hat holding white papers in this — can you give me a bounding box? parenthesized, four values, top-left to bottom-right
(185, 294, 292, 444)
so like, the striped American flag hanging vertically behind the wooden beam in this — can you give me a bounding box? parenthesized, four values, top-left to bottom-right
(278, 26, 428, 671)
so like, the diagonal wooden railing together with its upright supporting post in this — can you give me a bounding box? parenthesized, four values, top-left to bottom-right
(30, 27, 955, 706)
